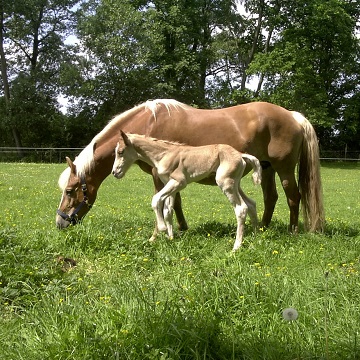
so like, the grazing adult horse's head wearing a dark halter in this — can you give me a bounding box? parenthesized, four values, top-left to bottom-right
(56, 157, 96, 229)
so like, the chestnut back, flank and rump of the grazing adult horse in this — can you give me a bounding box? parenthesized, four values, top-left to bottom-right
(150, 102, 303, 163)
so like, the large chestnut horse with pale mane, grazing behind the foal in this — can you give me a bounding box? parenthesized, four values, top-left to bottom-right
(56, 100, 324, 232)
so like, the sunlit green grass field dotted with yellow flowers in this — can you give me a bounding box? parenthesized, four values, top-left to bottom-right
(0, 163, 360, 360)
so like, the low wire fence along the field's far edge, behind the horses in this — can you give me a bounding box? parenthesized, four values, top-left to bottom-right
(0, 147, 360, 163)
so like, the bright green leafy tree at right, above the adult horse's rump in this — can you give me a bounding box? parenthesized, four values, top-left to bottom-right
(250, 0, 359, 146)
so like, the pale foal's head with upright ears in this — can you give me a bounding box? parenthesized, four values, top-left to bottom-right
(112, 130, 138, 179)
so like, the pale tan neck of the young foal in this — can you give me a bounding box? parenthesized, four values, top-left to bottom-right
(133, 138, 172, 167)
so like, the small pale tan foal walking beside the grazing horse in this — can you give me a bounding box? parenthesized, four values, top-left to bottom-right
(112, 130, 261, 251)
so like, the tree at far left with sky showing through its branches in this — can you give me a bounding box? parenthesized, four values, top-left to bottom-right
(1, 0, 79, 146)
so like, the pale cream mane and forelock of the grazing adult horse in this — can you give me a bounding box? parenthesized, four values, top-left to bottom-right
(58, 99, 191, 190)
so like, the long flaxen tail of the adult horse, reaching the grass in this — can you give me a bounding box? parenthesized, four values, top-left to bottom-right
(293, 112, 325, 232)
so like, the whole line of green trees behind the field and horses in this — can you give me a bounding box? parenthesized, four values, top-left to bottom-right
(0, 0, 360, 150)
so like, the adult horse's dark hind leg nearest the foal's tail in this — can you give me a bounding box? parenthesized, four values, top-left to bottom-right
(261, 163, 279, 227)
